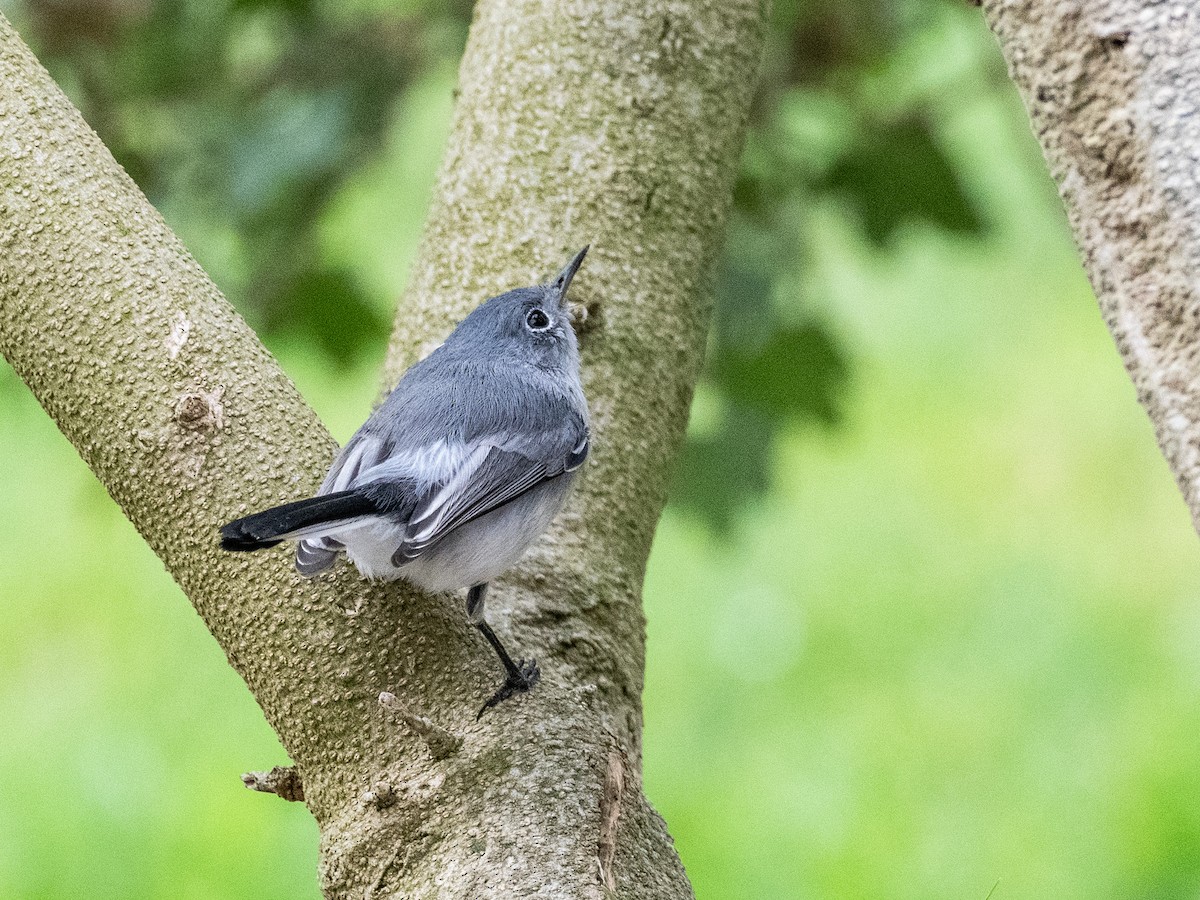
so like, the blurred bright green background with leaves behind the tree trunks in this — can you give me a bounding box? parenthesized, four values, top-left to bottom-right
(0, 0, 1200, 900)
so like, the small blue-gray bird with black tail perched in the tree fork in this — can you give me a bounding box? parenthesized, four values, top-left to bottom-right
(221, 247, 588, 715)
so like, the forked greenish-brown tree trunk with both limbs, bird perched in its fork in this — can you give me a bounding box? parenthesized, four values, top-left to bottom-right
(0, 0, 764, 898)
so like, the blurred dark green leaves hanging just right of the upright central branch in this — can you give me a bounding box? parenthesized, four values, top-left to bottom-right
(672, 0, 986, 530)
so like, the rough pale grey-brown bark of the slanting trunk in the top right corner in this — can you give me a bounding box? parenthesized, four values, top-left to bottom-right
(984, 0, 1200, 528)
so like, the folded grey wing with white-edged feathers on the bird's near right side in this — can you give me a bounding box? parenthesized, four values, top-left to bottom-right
(392, 416, 588, 565)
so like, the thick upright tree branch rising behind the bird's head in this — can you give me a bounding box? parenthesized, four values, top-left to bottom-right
(386, 0, 763, 755)
